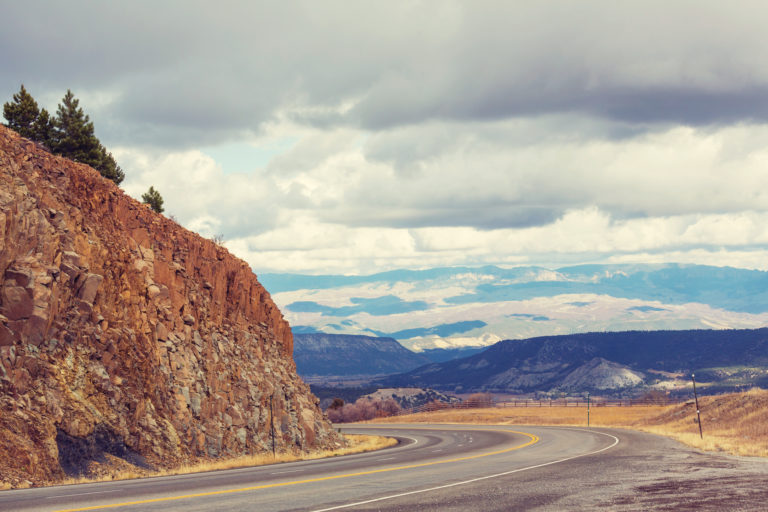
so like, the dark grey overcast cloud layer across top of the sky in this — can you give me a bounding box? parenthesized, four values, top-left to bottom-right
(6, 0, 768, 148)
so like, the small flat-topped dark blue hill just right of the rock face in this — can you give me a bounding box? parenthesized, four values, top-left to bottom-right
(293, 333, 430, 377)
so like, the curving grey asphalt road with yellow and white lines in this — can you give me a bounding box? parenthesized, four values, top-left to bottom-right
(0, 425, 768, 512)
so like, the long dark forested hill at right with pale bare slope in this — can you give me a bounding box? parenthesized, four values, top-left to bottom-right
(379, 329, 768, 394)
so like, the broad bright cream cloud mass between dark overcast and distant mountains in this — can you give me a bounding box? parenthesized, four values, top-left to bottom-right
(112, 114, 768, 274)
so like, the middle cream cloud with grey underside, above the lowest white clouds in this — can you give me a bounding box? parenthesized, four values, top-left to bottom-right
(320, 120, 768, 229)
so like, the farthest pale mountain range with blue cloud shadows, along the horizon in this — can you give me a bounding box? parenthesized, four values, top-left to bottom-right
(259, 264, 768, 351)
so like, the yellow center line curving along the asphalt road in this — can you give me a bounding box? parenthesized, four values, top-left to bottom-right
(55, 429, 539, 512)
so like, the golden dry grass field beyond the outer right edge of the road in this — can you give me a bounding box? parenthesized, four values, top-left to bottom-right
(374, 389, 768, 457)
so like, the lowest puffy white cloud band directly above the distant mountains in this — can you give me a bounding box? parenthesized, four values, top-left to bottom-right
(227, 208, 768, 274)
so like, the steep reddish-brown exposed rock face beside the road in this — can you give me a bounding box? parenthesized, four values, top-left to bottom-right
(0, 127, 337, 483)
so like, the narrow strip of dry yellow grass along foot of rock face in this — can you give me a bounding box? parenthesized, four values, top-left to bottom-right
(54, 434, 397, 489)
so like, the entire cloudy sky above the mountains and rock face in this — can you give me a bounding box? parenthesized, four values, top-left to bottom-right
(0, 0, 768, 274)
